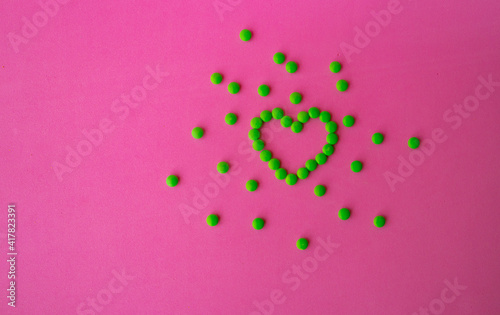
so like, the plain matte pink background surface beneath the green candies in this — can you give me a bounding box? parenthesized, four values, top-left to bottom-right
(0, 0, 500, 315)
